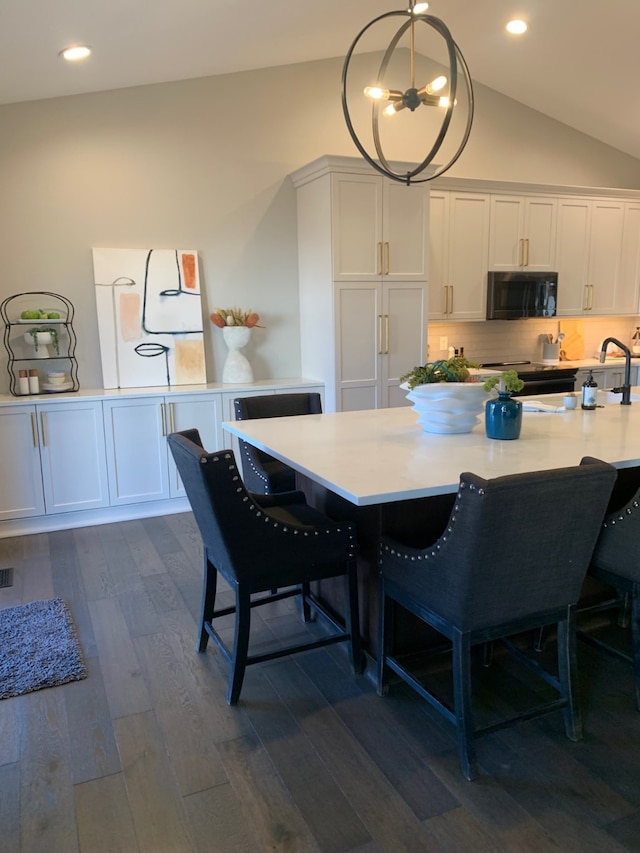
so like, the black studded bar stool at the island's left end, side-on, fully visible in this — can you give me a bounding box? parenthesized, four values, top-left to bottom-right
(167, 429, 364, 705)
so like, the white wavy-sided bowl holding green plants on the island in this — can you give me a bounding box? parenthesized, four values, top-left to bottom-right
(400, 382, 489, 435)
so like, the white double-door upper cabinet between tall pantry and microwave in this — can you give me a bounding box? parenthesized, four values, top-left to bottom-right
(429, 189, 490, 321)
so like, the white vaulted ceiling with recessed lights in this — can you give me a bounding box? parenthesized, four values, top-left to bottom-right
(5, 0, 640, 158)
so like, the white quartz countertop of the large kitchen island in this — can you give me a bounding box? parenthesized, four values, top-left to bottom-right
(223, 388, 640, 506)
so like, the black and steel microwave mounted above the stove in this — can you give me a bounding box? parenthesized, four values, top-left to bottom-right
(487, 271, 558, 320)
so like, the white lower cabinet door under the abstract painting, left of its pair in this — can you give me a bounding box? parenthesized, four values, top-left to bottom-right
(102, 397, 170, 506)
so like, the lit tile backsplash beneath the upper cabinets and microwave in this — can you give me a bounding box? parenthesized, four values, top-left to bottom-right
(427, 315, 640, 362)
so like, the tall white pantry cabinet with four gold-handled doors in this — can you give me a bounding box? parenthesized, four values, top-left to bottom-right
(291, 157, 429, 412)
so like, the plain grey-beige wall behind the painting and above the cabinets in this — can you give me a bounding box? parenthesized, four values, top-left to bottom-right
(0, 59, 640, 391)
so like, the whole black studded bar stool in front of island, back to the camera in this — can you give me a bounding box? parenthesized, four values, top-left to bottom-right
(378, 458, 616, 779)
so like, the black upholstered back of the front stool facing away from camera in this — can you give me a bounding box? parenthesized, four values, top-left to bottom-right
(390, 460, 615, 631)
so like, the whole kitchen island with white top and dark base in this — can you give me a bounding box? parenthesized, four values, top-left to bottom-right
(223, 388, 640, 657)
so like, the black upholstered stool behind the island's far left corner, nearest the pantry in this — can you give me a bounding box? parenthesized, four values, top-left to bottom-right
(233, 391, 322, 495)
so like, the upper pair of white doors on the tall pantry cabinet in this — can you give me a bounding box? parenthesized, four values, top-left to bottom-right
(331, 172, 428, 281)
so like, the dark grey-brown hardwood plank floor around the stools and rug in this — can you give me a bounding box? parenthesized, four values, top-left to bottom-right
(0, 514, 640, 853)
